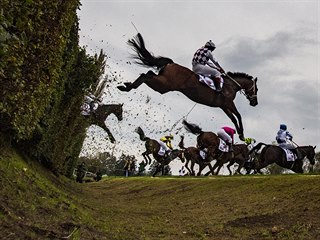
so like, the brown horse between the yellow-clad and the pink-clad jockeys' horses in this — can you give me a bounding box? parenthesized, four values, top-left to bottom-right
(178, 136, 213, 176)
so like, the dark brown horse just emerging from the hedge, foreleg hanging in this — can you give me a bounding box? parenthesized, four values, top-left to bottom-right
(89, 104, 123, 143)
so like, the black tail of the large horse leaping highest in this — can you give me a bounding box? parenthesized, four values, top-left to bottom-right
(128, 33, 173, 69)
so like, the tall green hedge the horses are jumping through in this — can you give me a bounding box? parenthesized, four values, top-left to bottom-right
(0, 0, 105, 175)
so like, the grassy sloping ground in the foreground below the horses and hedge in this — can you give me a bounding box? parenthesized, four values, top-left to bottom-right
(0, 149, 320, 240)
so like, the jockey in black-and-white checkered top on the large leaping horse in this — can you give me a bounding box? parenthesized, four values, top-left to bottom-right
(192, 40, 224, 92)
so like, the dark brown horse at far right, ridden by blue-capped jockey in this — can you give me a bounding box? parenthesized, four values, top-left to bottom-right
(249, 143, 316, 173)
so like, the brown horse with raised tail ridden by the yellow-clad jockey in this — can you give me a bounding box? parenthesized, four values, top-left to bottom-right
(135, 127, 184, 177)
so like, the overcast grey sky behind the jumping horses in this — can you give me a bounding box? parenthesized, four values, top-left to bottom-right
(78, 0, 320, 173)
